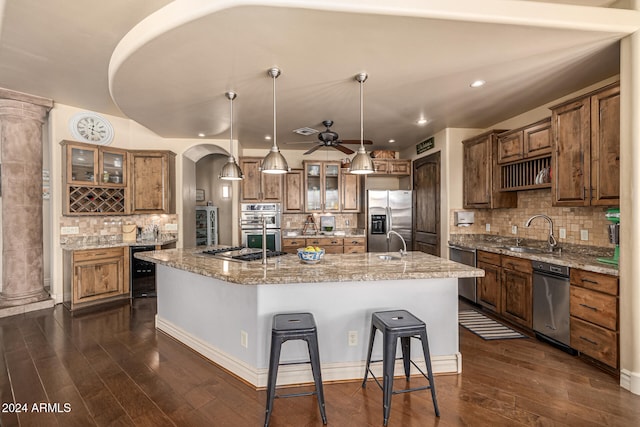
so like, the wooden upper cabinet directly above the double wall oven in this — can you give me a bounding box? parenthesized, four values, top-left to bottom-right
(240, 157, 283, 202)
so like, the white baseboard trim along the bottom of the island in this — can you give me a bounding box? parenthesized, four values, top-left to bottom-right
(156, 315, 462, 389)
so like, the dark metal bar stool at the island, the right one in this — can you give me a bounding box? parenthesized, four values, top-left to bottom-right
(362, 310, 440, 426)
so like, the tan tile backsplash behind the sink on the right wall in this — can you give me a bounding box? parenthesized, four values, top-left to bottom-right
(449, 189, 614, 247)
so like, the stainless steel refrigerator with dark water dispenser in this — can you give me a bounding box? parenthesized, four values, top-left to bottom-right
(367, 190, 413, 252)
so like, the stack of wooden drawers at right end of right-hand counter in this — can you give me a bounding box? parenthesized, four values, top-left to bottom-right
(570, 269, 620, 369)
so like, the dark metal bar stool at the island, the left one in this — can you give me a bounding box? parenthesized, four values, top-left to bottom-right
(264, 313, 327, 427)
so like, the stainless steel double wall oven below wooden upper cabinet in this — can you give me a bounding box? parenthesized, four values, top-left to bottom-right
(240, 203, 282, 251)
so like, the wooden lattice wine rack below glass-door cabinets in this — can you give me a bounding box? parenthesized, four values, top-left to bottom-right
(68, 186, 125, 215)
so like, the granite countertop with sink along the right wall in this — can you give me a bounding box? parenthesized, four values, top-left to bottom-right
(449, 234, 619, 276)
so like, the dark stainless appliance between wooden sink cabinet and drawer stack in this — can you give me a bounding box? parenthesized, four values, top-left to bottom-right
(531, 261, 573, 352)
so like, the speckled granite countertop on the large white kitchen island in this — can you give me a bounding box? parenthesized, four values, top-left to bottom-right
(135, 246, 484, 285)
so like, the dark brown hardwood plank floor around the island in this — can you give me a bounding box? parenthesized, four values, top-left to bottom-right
(0, 299, 640, 427)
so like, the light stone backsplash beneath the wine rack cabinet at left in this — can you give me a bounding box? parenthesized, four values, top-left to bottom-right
(59, 214, 178, 245)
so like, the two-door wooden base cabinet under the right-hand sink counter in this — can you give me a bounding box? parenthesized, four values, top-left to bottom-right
(476, 251, 533, 329)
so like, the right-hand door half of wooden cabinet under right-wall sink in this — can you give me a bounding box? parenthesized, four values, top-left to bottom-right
(500, 255, 533, 329)
